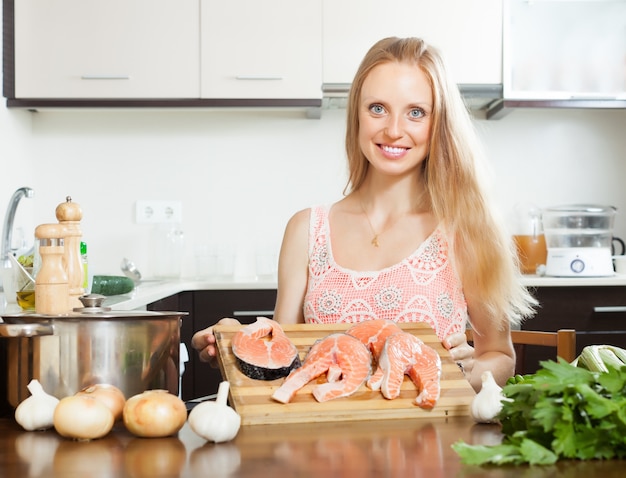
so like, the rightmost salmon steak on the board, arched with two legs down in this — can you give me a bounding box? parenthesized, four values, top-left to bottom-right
(368, 332, 441, 409)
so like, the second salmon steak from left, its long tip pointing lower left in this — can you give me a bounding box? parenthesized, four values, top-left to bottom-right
(272, 332, 372, 403)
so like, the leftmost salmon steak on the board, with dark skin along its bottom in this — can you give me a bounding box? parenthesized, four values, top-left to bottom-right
(232, 317, 300, 380)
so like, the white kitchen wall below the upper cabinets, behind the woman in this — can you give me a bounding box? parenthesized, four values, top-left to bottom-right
(1, 105, 626, 279)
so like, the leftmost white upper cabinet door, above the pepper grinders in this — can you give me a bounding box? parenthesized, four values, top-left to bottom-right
(14, 0, 200, 98)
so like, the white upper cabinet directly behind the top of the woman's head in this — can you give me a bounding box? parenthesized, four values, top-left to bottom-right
(323, 0, 502, 84)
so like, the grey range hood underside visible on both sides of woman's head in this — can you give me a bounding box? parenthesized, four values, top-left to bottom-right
(322, 83, 502, 116)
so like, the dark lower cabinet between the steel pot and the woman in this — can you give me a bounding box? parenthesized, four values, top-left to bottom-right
(148, 289, 276, 400)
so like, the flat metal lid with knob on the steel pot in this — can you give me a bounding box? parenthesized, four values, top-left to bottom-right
(2, 294, 189, 323)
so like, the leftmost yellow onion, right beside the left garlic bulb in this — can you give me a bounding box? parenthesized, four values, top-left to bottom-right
(53, 395, 115, 440)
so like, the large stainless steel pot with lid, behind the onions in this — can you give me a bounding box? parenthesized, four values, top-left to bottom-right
(0, 296, 187, 407)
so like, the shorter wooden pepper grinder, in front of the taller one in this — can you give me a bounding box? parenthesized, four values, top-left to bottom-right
(35, 224, 70, 315)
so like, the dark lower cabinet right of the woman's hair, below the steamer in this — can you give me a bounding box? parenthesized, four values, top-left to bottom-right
(521, 286, 626, 373)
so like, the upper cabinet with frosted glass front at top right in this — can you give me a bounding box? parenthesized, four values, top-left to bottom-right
(487, 0, 626, 118)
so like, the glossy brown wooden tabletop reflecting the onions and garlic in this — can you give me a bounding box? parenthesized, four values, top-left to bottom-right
(0, 417, 626, 478)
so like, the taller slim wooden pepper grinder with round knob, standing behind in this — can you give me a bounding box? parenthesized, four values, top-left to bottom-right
(55, 196, 85, 309)
